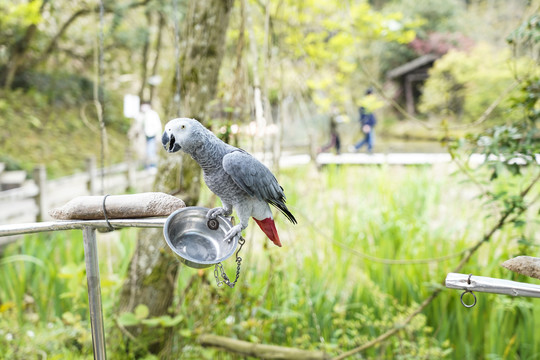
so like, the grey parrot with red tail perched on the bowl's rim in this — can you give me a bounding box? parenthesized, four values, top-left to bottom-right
(161, 118, 297, 246)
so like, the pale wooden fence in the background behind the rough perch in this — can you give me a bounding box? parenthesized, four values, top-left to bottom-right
(0, 158, 155, 245)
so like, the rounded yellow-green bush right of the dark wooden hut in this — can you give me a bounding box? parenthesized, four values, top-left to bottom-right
(418, 45, 533, 124)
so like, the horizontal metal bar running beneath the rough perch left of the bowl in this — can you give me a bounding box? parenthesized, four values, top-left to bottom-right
(0, 217, 167, 237)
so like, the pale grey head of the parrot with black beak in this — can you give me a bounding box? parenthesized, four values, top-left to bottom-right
(161, 118, 206, 154)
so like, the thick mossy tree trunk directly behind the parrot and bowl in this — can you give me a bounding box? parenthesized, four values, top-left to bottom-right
(119, 0, 233, 359)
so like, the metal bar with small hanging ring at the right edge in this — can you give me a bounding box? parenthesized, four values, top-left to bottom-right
(446, 273, 540, 298)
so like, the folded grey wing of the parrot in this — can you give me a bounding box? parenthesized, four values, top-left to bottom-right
(223, 150, 296, 224)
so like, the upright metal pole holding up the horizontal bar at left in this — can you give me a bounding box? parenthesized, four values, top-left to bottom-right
(83, 226, 107, 360)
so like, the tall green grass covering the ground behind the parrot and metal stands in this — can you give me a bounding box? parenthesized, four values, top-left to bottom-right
(0, 167, 540, 359)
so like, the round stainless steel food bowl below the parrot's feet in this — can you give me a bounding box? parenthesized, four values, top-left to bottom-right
(163, 207, 238, 269)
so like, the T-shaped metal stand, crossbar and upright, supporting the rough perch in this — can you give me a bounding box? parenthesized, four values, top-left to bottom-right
(0, 218, 166, 360)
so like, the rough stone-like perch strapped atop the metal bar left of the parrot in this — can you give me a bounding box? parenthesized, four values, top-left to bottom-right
(49, 192, 186, 220)
